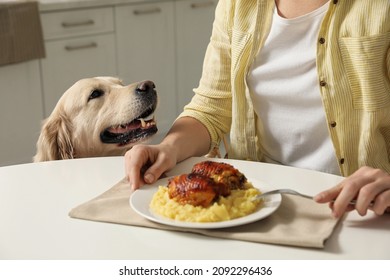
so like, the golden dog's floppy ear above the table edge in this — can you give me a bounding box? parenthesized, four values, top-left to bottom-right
(33, 112, 74, 162)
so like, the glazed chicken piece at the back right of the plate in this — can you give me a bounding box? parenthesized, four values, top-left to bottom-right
(192, 161, 247, 190)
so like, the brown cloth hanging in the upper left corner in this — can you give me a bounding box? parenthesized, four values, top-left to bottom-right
(0, 1, 45, 65)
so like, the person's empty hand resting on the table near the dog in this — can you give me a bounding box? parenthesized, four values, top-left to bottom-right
(125, 144, 176, 190)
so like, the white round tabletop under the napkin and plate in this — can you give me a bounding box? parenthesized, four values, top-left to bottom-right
(0, 157, 390, 260)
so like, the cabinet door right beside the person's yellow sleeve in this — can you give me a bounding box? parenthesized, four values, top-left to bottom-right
(175, 0, 218, 112)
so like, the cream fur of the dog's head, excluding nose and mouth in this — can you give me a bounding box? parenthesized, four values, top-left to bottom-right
(33, 77, 155, 162)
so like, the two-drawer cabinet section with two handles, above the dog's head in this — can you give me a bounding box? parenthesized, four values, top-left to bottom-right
(41, 7, 117, 117)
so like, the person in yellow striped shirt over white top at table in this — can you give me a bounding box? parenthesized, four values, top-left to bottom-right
(125, 0, 390, 217)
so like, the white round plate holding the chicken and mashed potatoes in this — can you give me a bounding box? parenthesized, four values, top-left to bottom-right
(130, 178, 282, 229)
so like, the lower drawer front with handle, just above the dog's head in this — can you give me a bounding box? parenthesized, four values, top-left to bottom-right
(41, 34, 117, 116)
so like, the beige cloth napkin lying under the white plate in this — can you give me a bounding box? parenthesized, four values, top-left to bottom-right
(69, 179, 338, 248)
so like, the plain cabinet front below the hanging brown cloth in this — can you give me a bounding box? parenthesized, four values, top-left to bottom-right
(0, 60, 43, 166)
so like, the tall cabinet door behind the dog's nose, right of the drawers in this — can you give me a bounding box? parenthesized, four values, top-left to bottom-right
(116, 2, 177, 135)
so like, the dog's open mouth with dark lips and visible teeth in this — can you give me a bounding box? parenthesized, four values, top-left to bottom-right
(100, 109, 157, 146)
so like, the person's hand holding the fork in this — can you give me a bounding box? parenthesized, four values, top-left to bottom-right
(314, 166, 390, 218)
